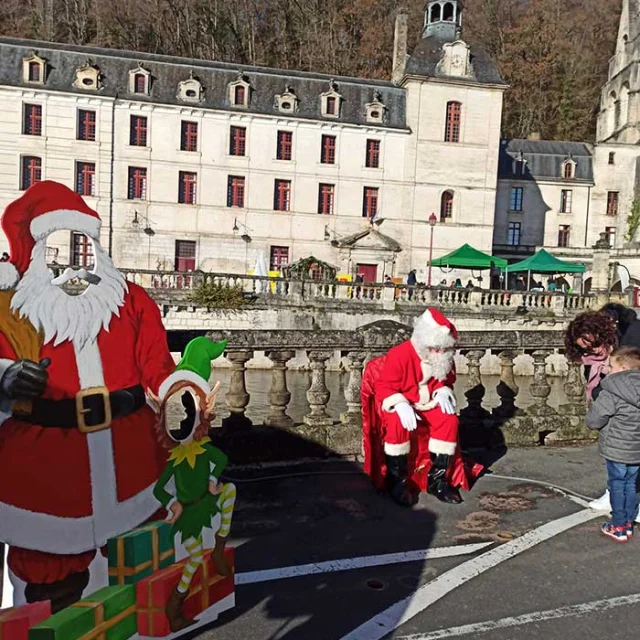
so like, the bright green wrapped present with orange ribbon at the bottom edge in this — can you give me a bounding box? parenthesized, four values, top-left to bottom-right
(29, 585, 138, 640)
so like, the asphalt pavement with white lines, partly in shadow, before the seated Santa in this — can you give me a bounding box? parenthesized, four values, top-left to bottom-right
(188, 446, 640, 640)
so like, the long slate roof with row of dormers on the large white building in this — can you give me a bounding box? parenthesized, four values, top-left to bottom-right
(0, 38, 406, 129)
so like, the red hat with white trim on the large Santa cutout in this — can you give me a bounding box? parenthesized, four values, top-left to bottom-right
(0, 180, 101, 289)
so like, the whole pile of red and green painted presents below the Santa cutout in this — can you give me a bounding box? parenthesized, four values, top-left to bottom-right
(7, 522, 234, 640)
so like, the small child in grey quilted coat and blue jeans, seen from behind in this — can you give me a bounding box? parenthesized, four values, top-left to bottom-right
(586, 347, 640, 542)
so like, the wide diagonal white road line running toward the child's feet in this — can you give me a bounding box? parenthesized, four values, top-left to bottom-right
(341, 509, 602, 640)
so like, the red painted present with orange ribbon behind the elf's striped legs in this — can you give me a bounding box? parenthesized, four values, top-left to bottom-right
(136, 549, 234, 638)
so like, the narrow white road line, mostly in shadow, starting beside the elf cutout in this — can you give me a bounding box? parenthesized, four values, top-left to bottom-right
(235, 542, 494, 584)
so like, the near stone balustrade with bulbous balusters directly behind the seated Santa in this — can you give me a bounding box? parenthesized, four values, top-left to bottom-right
(209, 322, 592, 456)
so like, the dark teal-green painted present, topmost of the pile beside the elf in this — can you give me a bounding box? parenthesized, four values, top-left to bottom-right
(107, 520, 175, 585)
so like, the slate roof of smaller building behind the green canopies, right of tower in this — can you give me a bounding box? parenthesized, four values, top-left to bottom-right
(498, 139, 593, 182)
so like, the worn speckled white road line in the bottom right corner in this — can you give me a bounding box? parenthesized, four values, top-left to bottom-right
(398, 593, 640, 640)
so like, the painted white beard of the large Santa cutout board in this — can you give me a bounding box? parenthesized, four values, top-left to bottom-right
(11, 238, 127, 349)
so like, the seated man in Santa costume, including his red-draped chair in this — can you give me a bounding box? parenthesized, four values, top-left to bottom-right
(362, 309, 477, 506)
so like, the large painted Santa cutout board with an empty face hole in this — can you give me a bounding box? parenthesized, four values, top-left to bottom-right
(0, 182, 175, 611)
